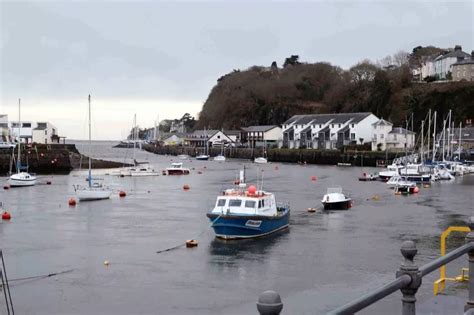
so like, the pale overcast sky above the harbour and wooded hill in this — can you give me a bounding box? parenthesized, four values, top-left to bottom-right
(0, 0, 474, 140)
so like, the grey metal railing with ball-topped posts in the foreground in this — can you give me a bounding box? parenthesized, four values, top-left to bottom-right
(257, 217, 474, 315)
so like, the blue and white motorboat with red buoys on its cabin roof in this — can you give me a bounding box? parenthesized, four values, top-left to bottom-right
(207, 173, 290, 239)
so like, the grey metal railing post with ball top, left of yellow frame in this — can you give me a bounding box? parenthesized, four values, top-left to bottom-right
(397, 241, 421, 315)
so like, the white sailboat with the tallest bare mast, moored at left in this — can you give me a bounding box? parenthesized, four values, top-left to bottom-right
(74, 95, 112, 201)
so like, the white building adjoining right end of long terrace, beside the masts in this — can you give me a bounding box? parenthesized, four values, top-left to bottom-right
(372, 119, 415, 151)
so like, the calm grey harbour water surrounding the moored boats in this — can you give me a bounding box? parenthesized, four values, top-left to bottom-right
(0, 143, 474, 314)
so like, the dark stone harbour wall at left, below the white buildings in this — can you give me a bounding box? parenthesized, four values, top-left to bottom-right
(0, 144, 128, 175)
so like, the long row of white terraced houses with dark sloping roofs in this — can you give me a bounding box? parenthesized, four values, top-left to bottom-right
(282, 112, 379, 150)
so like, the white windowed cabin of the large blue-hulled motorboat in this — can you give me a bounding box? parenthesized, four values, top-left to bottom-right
(211, 189, 277, 216)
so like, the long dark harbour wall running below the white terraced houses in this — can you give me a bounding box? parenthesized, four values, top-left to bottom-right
(143, 145, 403, 166)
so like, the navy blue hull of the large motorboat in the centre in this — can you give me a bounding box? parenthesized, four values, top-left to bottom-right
(207, 209, 290, 239)
